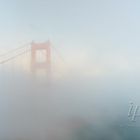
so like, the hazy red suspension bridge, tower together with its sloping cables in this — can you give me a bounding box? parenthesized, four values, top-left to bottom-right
(0, 40, 62, 74)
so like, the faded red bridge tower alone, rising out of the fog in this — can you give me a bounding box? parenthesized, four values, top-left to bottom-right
(31, 41, 51, 74)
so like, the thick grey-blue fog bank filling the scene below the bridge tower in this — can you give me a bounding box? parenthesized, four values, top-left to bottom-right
(0, 63, 140, 140)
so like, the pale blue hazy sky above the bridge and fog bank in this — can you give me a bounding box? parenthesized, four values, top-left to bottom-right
(0, 0, 140, 76)
